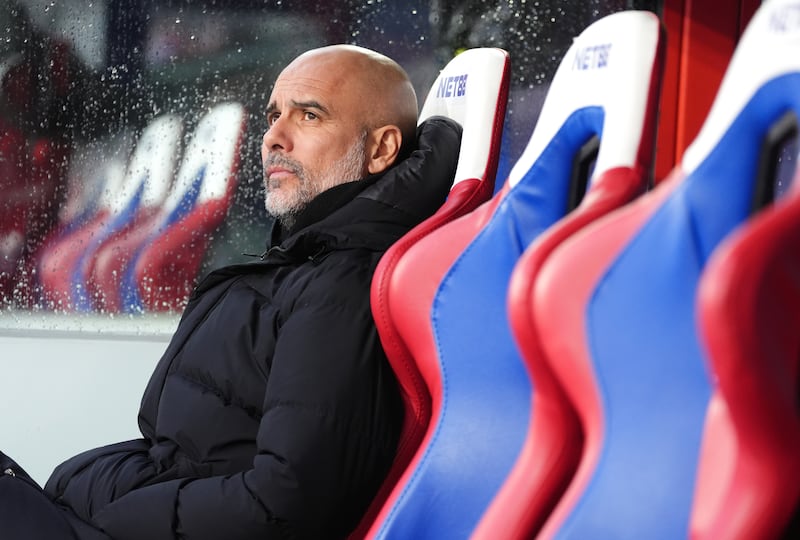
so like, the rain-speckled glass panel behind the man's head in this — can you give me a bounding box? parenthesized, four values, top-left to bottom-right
(0, 0, 658, 318)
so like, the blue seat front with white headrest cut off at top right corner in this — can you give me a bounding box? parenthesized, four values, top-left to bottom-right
(532, 0, 800, 539)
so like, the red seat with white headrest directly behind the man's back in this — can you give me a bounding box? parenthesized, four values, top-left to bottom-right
(351, 48, 510, 538)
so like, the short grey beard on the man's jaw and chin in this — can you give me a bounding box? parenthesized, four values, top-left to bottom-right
(264, 131, 367, 230)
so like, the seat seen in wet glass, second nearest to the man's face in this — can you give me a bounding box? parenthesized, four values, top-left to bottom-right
(39, 115, 181, 311)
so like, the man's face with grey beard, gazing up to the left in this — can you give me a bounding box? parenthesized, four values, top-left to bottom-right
(261, 52, 367, 219)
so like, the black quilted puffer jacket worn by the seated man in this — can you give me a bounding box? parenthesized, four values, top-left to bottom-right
(45, 118, 460, 540)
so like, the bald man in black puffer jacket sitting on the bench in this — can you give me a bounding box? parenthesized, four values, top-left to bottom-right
(0, 45, 460, 540)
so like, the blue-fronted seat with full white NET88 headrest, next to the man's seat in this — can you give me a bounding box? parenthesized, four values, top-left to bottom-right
(371, 13, 658, 538)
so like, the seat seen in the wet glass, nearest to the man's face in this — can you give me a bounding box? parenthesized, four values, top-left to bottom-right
(120, 102, 245, 312)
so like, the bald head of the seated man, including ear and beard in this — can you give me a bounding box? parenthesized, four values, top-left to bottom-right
(261, 45, 417, 226)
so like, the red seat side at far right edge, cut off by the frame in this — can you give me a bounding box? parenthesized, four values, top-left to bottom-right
(690, 165, 800, 539)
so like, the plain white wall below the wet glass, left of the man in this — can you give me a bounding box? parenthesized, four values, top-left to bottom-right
(0, 312, 177, 484)
